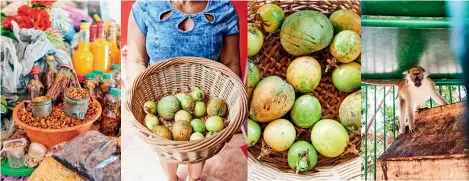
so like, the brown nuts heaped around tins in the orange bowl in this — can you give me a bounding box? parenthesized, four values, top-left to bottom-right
(18, 101, 98, 129)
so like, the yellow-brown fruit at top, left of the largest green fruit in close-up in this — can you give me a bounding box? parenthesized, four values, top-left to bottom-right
(257, 4, 285, 33)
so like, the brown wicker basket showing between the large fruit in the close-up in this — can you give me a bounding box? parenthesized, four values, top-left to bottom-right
(248, 0, 361, 179)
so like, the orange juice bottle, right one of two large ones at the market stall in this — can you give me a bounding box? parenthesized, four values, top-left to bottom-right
(91, 21, 111, 72)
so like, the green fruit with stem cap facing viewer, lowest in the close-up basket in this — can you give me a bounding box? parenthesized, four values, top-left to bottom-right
(288, 141, 318, 173)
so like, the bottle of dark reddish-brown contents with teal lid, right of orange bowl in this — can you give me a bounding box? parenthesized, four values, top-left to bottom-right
(100, 88, 121, 134)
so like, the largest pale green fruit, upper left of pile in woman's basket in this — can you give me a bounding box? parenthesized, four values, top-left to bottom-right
(157, 96, 181, 120)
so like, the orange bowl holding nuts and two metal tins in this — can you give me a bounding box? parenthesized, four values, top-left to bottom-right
(13, 99, 102, 148)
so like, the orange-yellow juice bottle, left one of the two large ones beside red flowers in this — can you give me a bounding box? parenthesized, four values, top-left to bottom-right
(72, 20, 94, 82)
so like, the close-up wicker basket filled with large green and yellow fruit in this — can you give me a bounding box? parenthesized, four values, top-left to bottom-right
(248, 1, 361, 175)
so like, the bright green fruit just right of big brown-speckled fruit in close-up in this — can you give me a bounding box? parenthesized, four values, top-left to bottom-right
(290, 94, 322, 128)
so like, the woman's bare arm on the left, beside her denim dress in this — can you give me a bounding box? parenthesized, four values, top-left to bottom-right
(126, 11, 148, 85)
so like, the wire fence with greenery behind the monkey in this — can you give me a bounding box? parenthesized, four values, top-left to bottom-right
(361, 79, 467, 180)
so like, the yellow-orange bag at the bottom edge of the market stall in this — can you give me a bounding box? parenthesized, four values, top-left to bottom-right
(28, 158, 85, 181)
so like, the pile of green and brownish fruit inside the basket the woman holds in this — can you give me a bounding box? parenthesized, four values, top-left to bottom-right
(143, 88, 228, 141)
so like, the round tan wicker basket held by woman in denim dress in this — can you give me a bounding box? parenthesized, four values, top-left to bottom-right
(126, 57, 248, 163)
